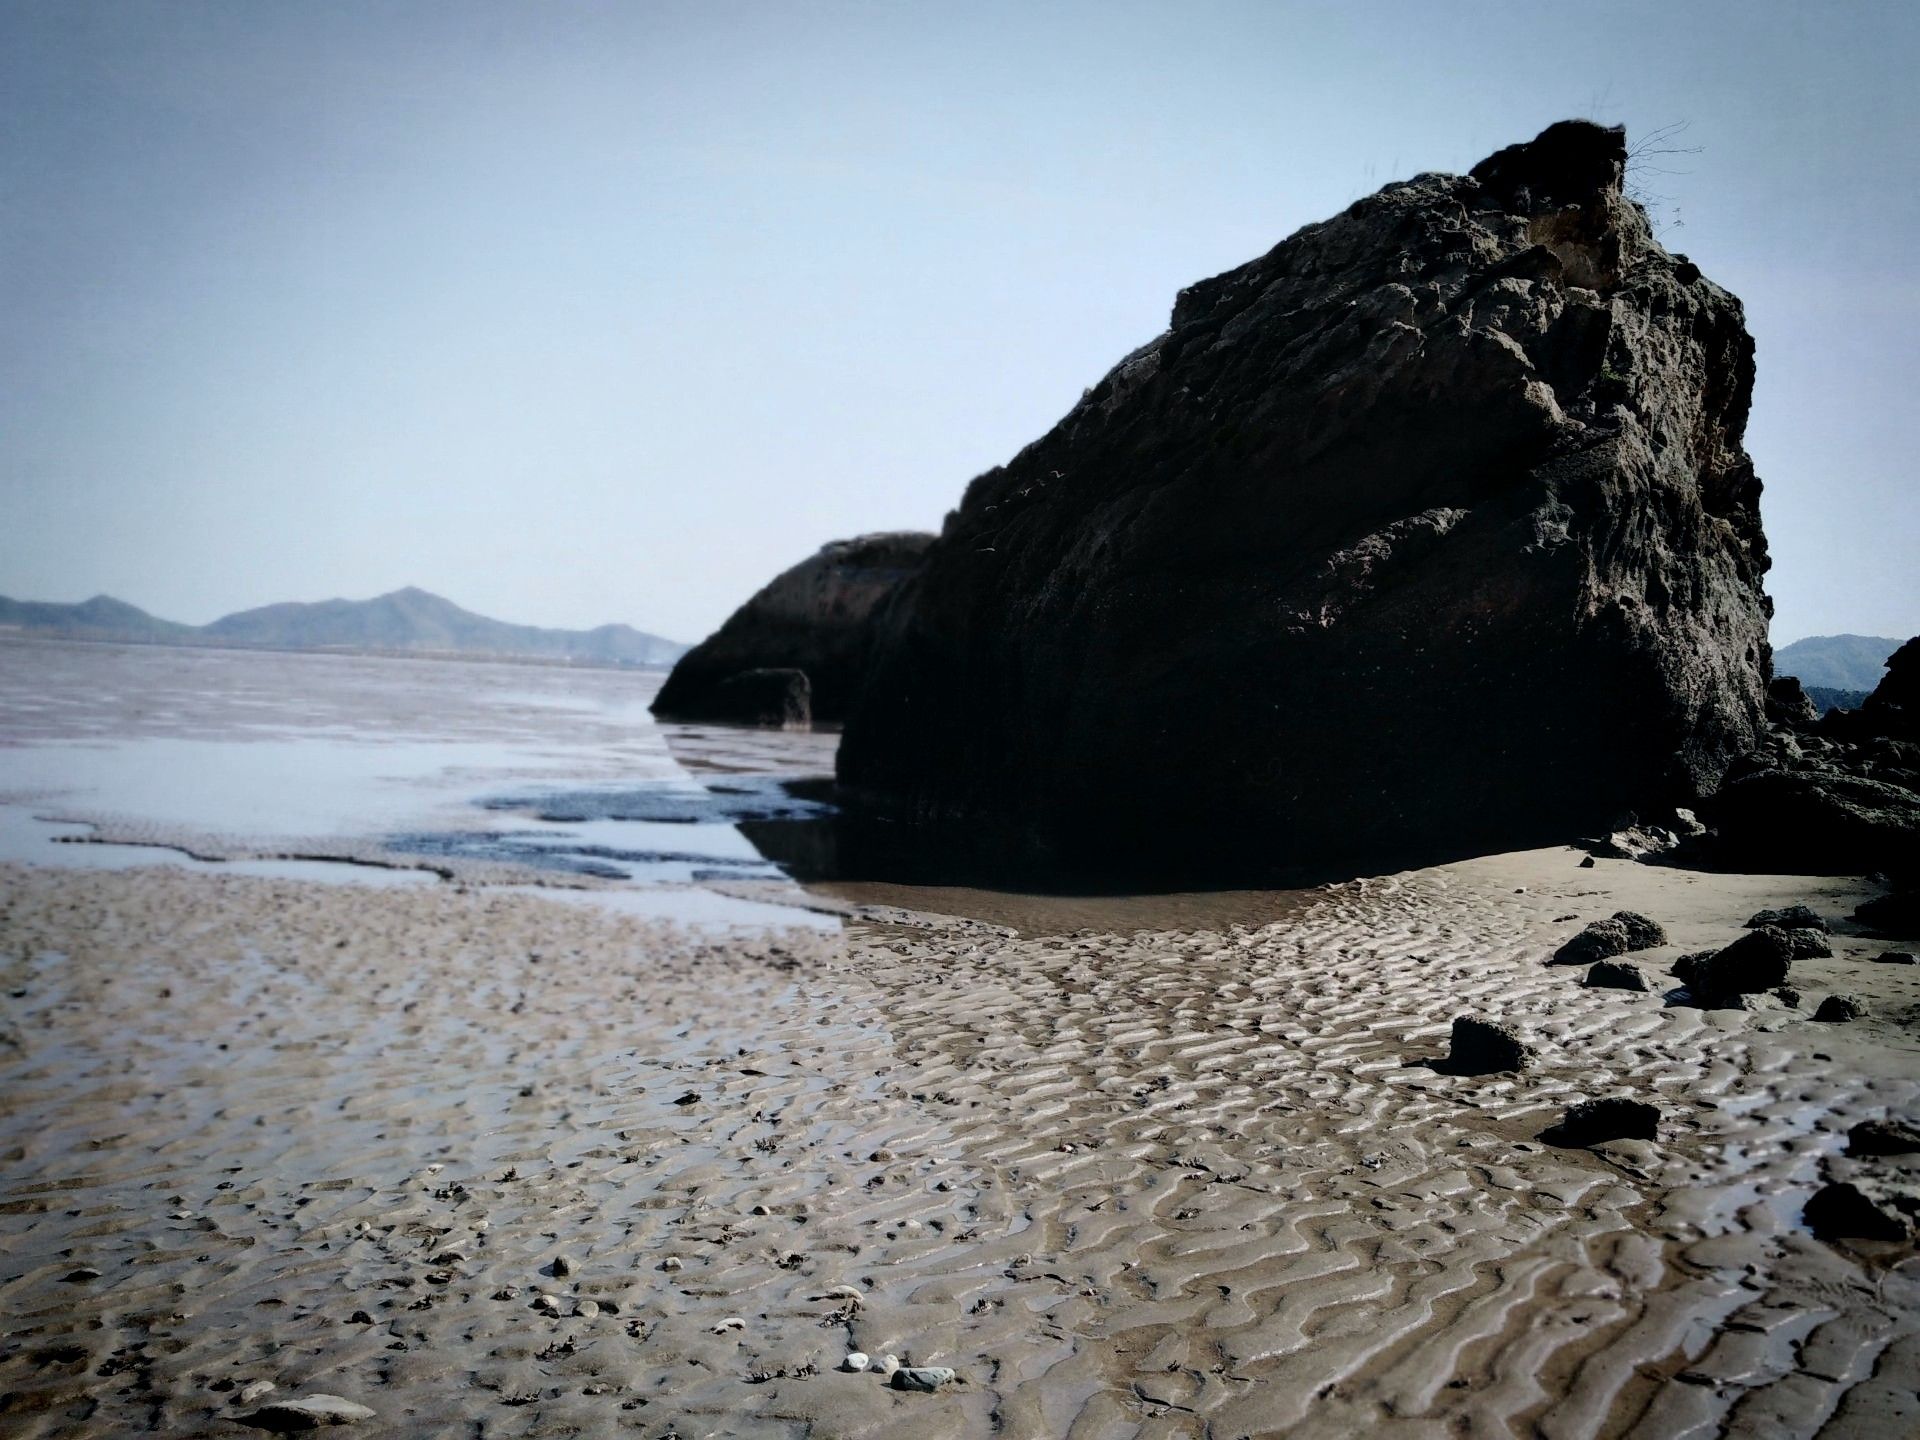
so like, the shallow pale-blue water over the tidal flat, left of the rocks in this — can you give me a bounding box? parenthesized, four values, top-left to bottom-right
(0, 639, 831, 925)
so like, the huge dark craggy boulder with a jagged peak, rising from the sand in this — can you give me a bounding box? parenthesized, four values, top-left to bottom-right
(839, 121, 1770, 877)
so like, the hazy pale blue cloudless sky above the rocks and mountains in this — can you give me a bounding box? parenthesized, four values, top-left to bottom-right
(0, 0, 1920, 641)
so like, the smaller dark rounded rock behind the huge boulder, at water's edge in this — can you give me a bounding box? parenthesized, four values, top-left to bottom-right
(653, 530, 933, 726)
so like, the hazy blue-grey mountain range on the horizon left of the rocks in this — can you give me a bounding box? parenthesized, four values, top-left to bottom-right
(0, 586, 687, 666)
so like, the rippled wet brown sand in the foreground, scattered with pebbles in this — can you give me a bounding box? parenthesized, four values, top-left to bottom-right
(0, 851, 1920, 1440)
